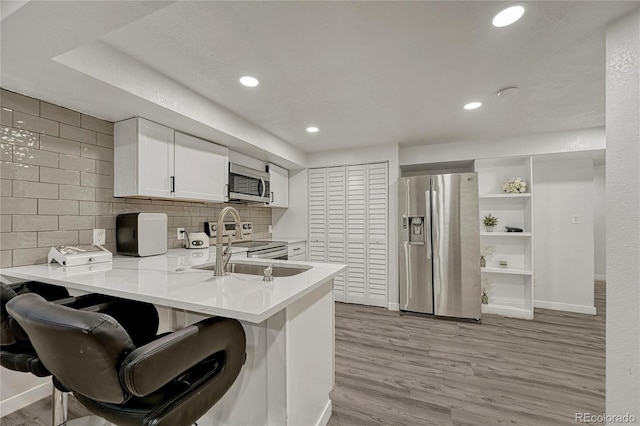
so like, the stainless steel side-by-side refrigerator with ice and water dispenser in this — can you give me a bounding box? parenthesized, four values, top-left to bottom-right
(398, 173, 481, 320)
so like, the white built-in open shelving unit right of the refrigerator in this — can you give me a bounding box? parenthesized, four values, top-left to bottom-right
(475, 156, 534, 319)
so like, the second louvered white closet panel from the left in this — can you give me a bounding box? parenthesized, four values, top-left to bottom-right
(327, 166, 346, 302)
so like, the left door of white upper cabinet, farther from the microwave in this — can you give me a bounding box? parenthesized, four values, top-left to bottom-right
(136, 118, 174, 198)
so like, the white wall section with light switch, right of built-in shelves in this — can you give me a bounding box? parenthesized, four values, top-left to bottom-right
(532, 159, 596, 314)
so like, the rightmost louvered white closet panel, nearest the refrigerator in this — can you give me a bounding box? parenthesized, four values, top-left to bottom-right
(367, 163, 389, 307)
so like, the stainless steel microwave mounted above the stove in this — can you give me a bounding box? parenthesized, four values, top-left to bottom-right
(229, 163, 271, 203)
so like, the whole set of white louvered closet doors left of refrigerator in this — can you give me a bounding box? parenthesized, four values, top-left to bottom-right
(309, 163, 389, 307)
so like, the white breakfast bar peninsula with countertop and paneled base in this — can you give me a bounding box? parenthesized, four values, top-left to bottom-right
(0, 248, 346, 426)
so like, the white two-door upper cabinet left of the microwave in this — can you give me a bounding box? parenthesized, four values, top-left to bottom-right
(113, 117, 229, 202)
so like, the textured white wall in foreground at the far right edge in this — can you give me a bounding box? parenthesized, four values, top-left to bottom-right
(606, 8, 640, 424)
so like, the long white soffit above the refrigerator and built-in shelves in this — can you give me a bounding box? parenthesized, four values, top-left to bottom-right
(399, 127, 606, 166)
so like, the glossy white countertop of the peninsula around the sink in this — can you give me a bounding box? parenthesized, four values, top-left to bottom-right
(0, 247, 346, 323)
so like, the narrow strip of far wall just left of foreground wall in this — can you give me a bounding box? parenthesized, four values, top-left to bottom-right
(593, 164, 607, 280)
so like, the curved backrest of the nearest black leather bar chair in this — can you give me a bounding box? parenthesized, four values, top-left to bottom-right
(6, 293, 135, 404)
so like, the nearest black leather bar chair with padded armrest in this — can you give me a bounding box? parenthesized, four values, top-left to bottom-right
(7, 294, 246, 426)
